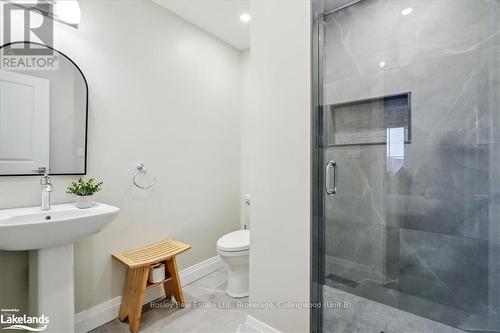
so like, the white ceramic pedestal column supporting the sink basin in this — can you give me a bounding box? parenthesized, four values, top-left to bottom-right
(29, 243, 75, 333)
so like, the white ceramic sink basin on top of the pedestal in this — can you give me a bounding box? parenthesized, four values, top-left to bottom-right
(0, 203, 119, 251)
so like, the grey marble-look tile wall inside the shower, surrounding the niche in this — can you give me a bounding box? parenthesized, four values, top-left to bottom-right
(324, 0, 500, 331)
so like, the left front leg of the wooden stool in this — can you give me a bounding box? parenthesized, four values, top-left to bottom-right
(119, 266, 149, 333)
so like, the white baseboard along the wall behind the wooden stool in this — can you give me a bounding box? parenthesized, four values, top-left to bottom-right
(75, 255, 224, 333)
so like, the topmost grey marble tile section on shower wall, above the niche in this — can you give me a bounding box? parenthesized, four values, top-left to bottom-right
(325, 0, 500, 81)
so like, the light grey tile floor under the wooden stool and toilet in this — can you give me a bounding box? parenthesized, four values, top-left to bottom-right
(91, 268, 249, 333)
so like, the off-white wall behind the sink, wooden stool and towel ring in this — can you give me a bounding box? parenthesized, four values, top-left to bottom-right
(0, 0, 241, 311)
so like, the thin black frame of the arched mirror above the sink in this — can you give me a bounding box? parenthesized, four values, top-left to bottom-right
(0, 41, 89, 177)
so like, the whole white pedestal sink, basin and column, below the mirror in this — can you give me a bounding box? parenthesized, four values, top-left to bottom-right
(0, 203, 119, 333)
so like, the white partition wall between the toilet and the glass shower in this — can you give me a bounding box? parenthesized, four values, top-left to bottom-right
(243, 0, 311, 332)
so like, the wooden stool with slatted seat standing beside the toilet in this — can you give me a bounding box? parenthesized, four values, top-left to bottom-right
(113, 239, 191, 333)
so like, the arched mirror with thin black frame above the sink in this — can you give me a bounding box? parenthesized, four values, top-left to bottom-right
(0, 42, 88, 176)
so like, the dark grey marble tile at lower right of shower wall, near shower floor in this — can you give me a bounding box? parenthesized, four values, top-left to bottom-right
(398, 230, 488, 313)
